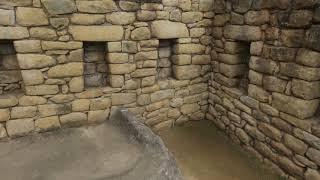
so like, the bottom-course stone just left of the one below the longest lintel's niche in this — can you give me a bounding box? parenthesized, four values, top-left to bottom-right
(60, 112, 88, 126)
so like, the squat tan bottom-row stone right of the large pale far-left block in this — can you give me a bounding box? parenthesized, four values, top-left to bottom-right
(35, 116, 60, 132)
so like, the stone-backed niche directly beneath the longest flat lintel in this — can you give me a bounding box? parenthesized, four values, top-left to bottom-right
(83, 42, 107, 88)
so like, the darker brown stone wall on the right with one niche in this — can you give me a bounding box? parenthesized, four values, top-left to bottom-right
(206, 0, 320, 180)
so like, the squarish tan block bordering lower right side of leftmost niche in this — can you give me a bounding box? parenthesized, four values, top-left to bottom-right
(21, 70, 44, 86)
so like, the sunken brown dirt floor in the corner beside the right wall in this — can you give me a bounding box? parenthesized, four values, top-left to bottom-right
(159, 121, 281, 180)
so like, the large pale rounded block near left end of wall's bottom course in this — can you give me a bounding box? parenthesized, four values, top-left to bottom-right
(6, 119, 34, 137)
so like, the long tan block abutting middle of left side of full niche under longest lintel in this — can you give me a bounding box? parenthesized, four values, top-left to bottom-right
(48, 62, 83, 78)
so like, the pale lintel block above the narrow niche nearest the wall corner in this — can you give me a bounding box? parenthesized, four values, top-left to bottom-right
(151, 20, 189, 39)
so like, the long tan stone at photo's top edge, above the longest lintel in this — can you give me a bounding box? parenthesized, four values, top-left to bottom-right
(76, 0, 118, 14)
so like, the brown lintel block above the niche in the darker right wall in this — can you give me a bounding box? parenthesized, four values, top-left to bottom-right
(223, 25, 262, 41)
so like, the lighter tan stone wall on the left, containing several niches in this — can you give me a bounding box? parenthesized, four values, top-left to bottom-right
(0, 0, 214, 139)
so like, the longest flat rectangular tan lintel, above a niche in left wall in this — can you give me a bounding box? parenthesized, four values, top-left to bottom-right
(69, 26, 124, 41)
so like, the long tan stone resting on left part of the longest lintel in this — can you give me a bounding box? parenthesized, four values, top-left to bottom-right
(70, 14, 105, 25)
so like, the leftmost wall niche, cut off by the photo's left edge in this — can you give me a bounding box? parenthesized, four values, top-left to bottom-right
(0, 41, 22, 95)
